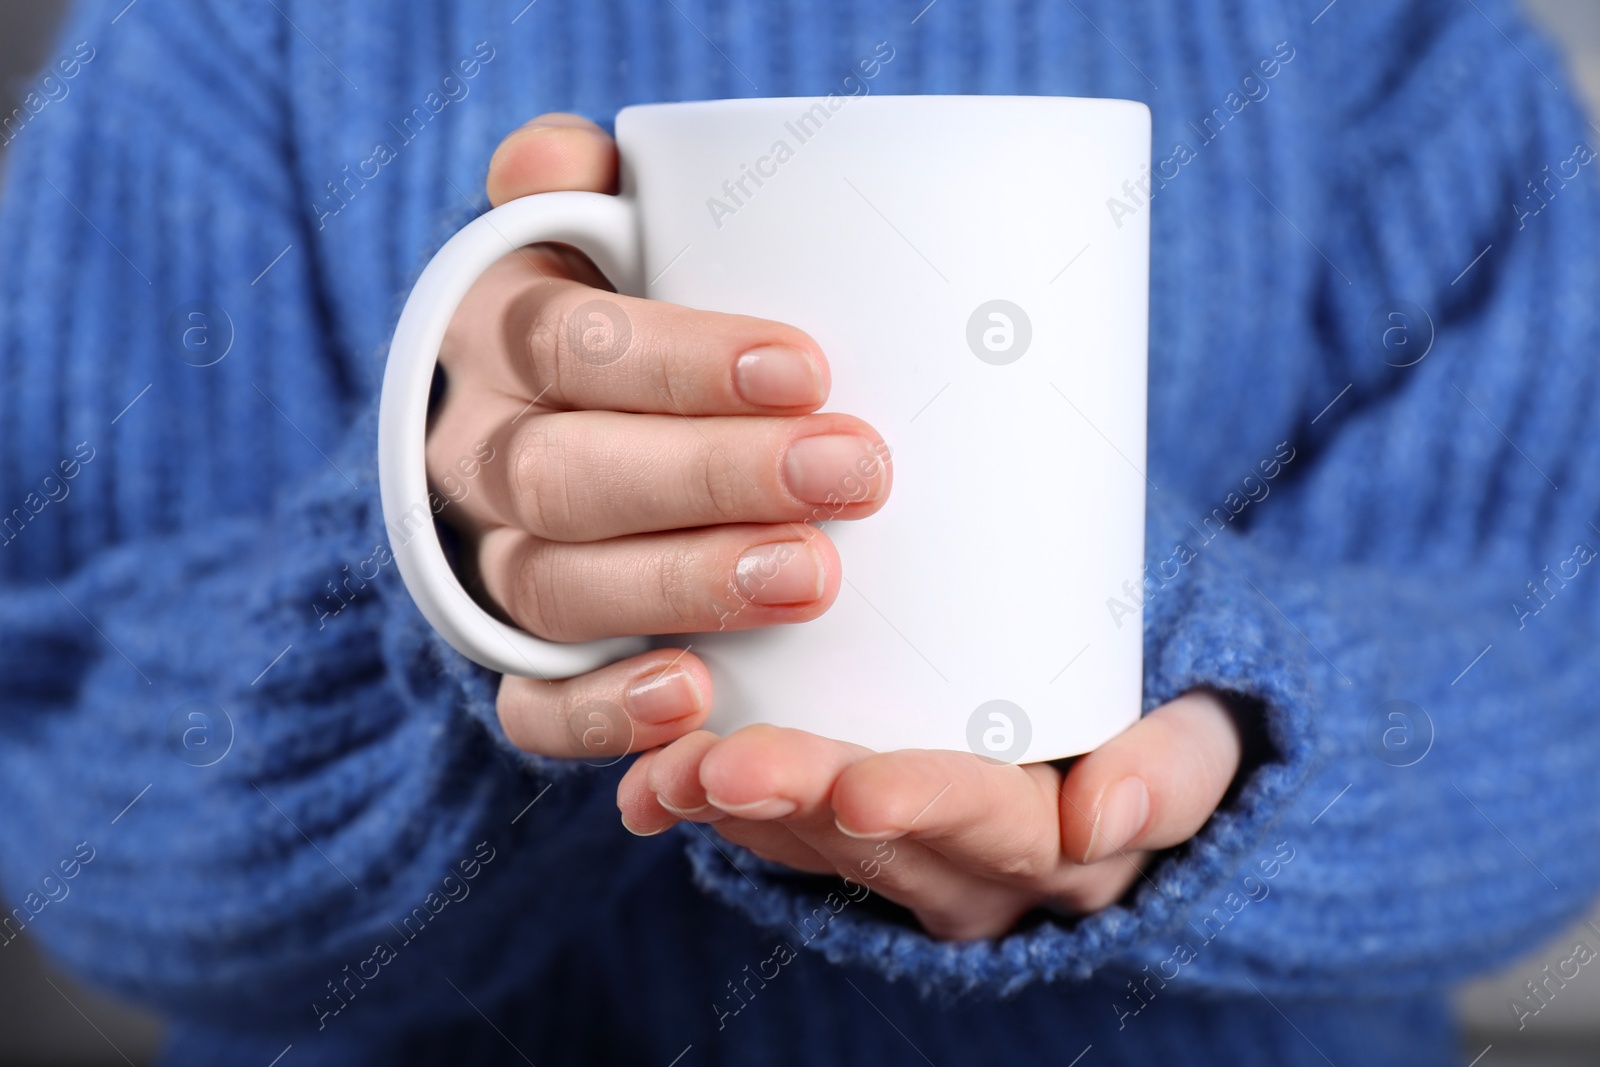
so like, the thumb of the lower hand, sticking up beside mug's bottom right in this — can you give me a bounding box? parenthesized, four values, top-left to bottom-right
(1061, 691, 1240, 864)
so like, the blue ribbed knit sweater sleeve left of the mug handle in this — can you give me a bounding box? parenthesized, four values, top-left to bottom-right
(0, 0, 621, 1029)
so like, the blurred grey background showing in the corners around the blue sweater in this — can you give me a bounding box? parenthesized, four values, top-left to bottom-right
(0, 0, 1600, 1067)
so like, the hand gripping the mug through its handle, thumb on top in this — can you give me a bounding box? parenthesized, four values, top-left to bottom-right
(427, 114, 891, 760)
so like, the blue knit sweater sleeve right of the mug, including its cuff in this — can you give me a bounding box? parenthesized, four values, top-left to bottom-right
(691, 0, 1600, 1013)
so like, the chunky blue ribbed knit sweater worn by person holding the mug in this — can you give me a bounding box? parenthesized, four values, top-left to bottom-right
(0, 0, 1600, 1067)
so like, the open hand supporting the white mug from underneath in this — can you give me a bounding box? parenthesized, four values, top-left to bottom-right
(618, 691, 1242, 939)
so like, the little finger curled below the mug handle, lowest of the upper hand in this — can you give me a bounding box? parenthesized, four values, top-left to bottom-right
(494, 648, 712, 761)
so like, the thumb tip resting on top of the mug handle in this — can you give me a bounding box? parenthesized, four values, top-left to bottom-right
(486, 112, 616, 206)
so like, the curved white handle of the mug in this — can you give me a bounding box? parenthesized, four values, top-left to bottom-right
(378, 192, 650, 678)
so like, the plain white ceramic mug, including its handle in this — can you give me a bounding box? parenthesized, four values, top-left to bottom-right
(379, 96, 1150, 761)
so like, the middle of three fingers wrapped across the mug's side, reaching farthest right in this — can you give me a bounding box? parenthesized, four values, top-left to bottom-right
(444, 406, 893, 541)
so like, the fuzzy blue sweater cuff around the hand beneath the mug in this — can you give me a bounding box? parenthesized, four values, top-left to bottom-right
(680, 501, 1318, 1000)
